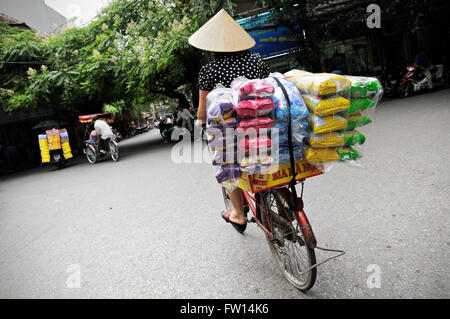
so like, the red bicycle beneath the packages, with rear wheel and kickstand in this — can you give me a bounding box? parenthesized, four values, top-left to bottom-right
(222, 179, 345, 291)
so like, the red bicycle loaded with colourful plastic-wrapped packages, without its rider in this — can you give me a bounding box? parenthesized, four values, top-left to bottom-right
(206, 70, 382, 291)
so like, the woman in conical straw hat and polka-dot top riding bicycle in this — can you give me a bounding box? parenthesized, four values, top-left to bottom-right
(189, 9, 270, 233)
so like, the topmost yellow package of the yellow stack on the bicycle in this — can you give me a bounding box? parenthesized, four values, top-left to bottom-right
(284, 70, 351, 96)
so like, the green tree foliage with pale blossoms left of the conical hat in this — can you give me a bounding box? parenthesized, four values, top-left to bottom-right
(0, 0, 222, 117)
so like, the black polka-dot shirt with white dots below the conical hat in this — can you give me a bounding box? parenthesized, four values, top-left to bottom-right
(198, 50, 270, 91)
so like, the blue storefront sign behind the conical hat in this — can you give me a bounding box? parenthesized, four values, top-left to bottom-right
(237, 12, 299, 58)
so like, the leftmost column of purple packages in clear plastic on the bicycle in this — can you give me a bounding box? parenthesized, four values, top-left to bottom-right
(206, 86, 241, 183)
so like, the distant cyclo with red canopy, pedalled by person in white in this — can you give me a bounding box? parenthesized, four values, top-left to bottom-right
(78, 113, 119, 164)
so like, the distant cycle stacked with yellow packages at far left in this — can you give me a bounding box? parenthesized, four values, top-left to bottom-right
(38, 128, 73, 168)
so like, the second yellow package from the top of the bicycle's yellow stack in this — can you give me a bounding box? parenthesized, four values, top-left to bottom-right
(303, 94, 350, 116)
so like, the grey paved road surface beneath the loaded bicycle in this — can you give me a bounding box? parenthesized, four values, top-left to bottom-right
(0, 90, 450, 298)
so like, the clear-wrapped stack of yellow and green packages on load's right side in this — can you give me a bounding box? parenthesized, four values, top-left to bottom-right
(285, 70, 382, 163)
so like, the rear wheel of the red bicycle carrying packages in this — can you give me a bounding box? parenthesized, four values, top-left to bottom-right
(258, 190, 317, 291)
